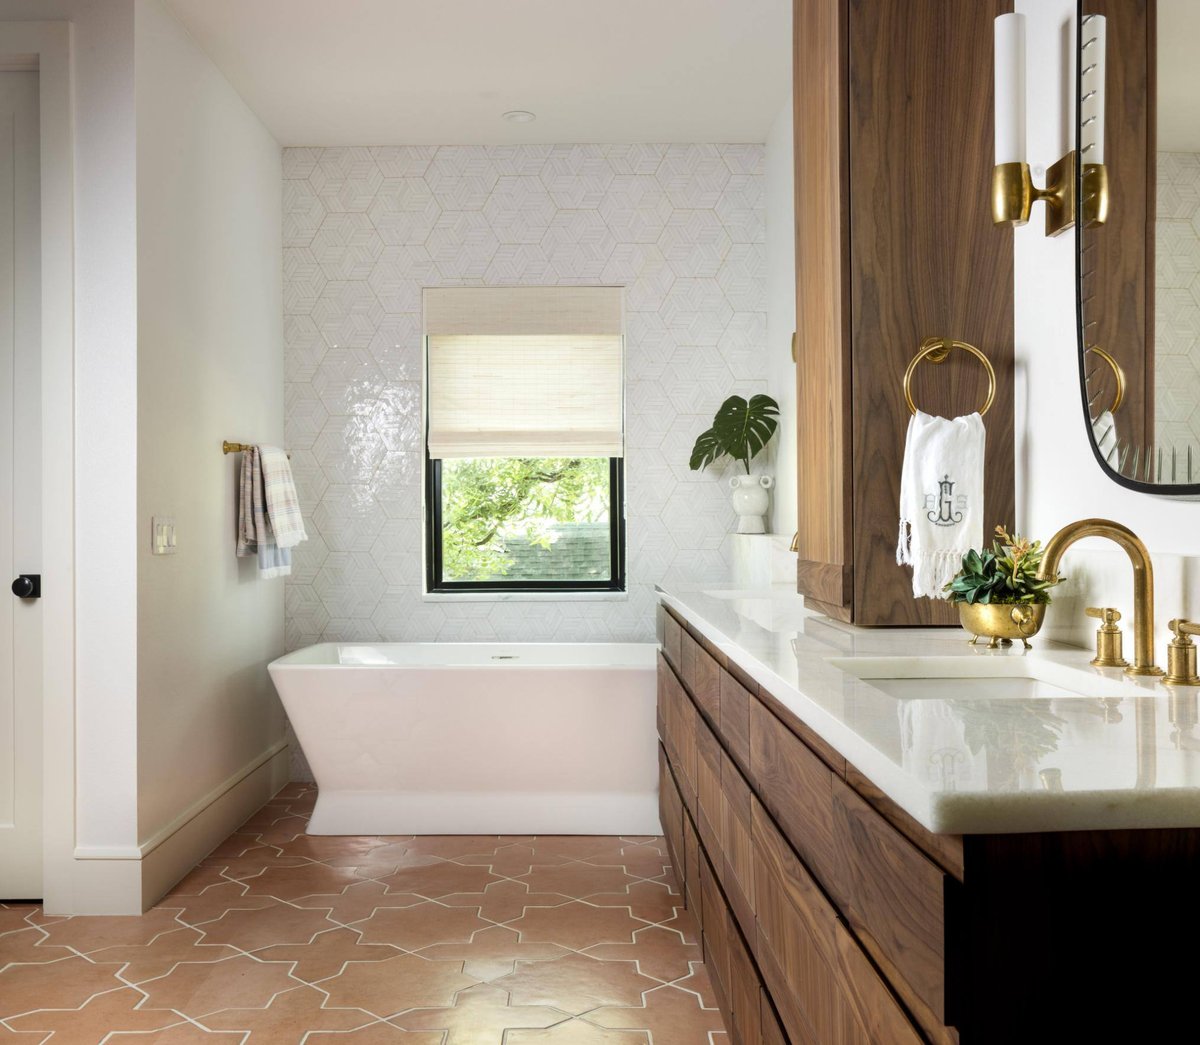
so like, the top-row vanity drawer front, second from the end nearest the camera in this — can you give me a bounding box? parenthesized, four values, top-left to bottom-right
(750, 701, 841, 902)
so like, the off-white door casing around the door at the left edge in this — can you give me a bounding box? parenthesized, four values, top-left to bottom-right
(0, 22, 76, 911)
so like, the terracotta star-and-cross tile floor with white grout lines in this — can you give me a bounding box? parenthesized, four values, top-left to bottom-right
(0, 785, 726, 1045)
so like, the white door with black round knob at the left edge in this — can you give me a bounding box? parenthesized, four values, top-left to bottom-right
(0, 72, 42, 900)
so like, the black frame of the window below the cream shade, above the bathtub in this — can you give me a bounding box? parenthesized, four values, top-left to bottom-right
(425, 450, 625, 595)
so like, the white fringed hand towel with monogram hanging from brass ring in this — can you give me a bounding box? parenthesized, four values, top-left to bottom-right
(896, 410, 985, 599)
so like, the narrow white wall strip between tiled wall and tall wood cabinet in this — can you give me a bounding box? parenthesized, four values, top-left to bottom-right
(764, 96, 797, 539)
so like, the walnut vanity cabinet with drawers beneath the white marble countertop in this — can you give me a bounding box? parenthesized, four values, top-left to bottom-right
(659, 608, 1200, 1045)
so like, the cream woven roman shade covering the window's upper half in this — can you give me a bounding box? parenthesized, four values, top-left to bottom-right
(425, 287, 624, 458)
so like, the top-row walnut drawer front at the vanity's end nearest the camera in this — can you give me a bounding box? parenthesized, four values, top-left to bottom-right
(834, 780, 946, 1022)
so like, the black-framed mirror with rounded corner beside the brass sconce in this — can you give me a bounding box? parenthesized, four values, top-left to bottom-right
(1075, 0, 1200, 497)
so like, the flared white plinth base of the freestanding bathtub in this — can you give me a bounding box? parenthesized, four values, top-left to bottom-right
(308, 791, 662, 835)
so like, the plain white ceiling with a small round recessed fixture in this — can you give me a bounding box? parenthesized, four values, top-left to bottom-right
(167, 0, 791, 145)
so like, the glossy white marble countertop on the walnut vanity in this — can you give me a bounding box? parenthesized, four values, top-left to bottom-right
(660, 585, 1200, 834)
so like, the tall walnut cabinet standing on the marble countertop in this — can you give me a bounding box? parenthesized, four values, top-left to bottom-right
(793, 0, 1014, 625)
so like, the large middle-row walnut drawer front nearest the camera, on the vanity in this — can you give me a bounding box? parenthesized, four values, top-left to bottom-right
(751, 799, 922, 1045)
